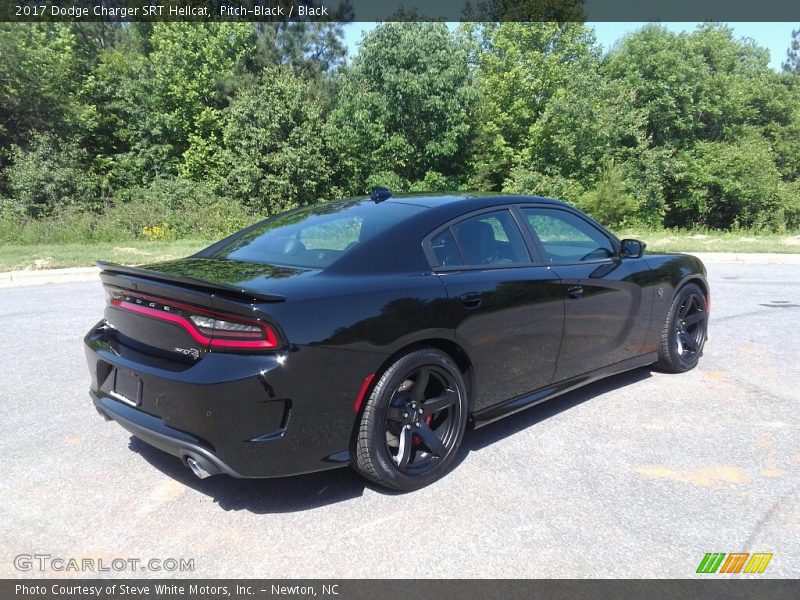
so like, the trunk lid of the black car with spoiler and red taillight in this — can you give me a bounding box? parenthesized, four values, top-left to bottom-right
(98, 258, 285, 361)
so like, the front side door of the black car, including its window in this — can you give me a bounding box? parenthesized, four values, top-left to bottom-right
(520, 206, 652, 381)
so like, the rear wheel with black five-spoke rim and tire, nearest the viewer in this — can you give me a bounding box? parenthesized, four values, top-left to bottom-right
(353, 348, 468, 492)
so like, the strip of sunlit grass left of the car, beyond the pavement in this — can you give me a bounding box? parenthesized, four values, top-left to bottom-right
(0, 240, 211, 272)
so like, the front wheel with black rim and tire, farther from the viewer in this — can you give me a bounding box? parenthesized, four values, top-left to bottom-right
(656, 283, 708, 373)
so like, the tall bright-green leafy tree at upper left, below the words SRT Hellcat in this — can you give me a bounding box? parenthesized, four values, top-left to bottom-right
(81, 23, 253, 188)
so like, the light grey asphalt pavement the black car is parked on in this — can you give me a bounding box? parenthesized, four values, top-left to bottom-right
(0, 263, 800, 578)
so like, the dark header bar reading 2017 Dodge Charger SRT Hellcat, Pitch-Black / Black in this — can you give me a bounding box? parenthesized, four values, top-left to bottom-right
(0, 0, 800, 22)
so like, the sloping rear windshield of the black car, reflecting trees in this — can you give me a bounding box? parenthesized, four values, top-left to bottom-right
(211, 200, 423, 269)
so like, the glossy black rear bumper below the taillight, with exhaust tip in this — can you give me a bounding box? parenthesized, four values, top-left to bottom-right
(85, 321, 385, 478)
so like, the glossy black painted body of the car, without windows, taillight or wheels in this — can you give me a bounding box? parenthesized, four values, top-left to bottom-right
(85, 195, 708, 477)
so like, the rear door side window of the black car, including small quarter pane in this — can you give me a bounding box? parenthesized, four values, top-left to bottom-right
(440, 210, 530, 266)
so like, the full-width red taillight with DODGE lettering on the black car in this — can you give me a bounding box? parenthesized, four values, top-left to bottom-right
(109, 290, 278, 350)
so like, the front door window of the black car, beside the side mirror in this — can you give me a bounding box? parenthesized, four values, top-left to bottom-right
(522, 208, 614, 263)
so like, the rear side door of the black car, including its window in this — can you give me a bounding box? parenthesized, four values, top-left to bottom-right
(426, 207, 564, 410)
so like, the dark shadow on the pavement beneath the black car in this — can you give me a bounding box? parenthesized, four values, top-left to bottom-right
(129, 368, 651, 514)
